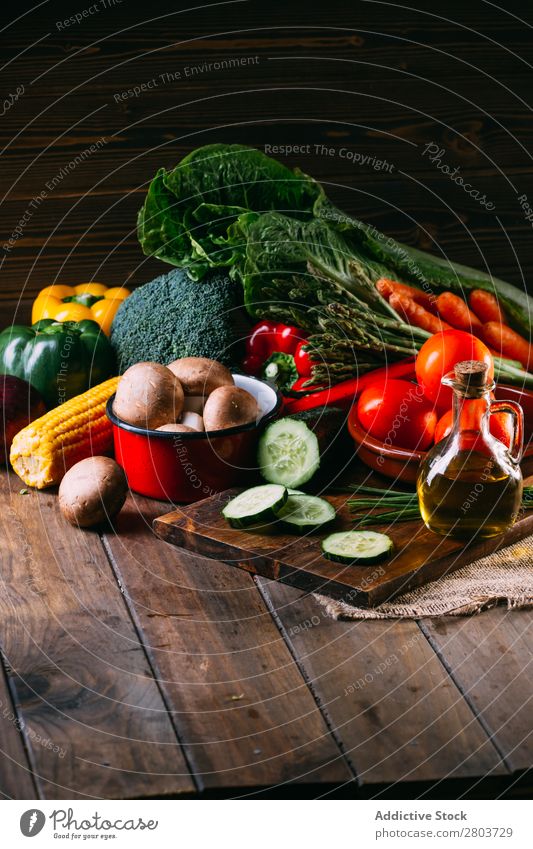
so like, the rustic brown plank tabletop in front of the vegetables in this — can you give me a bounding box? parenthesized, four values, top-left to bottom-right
(0, 473, 533, 799)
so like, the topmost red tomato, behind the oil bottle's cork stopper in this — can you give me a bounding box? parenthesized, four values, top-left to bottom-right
(415, 330, 494, 412)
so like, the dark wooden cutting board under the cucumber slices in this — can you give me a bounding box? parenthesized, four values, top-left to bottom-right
(153, 480, 533, 607)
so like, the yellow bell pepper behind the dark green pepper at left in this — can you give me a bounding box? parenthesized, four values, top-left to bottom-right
(31, 283, 130, 336)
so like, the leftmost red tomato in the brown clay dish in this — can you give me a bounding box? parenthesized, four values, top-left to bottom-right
(357, 380, 437, 451)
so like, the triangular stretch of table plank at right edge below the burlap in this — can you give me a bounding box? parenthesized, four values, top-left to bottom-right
(421, 607, 533, 770)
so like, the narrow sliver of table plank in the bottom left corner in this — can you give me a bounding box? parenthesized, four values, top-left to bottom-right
(0, 664, 37, 799)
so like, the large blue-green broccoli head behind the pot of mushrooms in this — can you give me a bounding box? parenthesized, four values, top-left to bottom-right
(111, 269, 243, 373)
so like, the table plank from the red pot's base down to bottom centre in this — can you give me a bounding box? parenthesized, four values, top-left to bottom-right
(106, 497, 353, 789)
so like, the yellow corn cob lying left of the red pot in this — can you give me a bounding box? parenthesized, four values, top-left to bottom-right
(9, 377, 119, 489)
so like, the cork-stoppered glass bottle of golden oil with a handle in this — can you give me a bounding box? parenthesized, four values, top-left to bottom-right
(417, 360, 523, 541)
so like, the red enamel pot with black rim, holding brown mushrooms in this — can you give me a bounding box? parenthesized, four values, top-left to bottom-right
(106, 374, 281, 503)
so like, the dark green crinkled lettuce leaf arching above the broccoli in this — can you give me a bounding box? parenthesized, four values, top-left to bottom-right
(137, 144, 319, 280)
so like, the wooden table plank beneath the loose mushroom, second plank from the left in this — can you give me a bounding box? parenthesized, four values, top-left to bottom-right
(0, 474, 194, 798)
